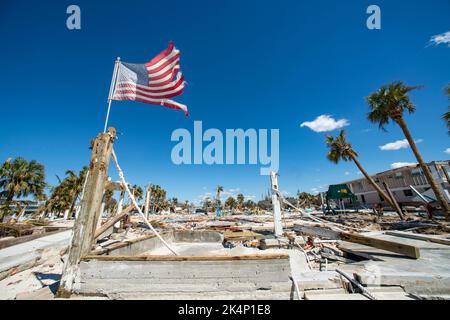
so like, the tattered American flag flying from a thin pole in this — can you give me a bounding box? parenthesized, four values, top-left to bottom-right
(111, 42, 188, 116)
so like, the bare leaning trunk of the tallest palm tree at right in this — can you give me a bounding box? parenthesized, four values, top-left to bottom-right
(394, 118, 450, 220)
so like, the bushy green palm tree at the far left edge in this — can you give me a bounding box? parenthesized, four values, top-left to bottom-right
(0, 157, 46, 222)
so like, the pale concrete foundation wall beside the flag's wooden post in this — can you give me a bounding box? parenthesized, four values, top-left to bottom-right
(75, 231, 294, 299)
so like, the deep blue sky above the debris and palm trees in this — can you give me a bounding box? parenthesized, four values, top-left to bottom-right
(0, 0, 450, 201)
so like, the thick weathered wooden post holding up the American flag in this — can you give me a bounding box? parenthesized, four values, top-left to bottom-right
(57, 128, 116, 298)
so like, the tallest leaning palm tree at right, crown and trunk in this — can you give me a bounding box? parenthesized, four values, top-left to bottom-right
(367, 81, 450, 219)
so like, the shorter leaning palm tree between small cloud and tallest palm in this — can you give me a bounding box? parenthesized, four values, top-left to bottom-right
(326, 130, 404, 220)
